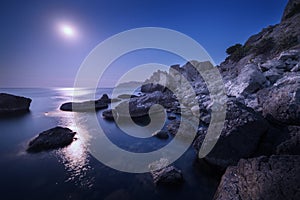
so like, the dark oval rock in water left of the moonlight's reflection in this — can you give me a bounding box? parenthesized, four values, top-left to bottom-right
(27, 126, 76, 152)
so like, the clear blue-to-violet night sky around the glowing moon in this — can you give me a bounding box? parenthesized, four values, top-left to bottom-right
(0, 0, 287, 88)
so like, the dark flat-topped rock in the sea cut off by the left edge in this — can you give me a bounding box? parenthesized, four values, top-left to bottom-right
(0, 93, 32, 115)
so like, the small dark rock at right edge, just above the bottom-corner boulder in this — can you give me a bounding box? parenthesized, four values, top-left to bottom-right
(276, 126, 300, 155)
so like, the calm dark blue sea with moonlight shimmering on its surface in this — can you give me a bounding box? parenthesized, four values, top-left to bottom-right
(0, 88, 218, 200)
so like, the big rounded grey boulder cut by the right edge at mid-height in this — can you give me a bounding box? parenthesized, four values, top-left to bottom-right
(257, 73, 300, 125)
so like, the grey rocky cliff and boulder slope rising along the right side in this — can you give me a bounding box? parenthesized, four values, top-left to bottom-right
(141, 0, 300, 199)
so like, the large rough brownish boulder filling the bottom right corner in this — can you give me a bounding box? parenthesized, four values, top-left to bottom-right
(214, 155, 300, 200)
